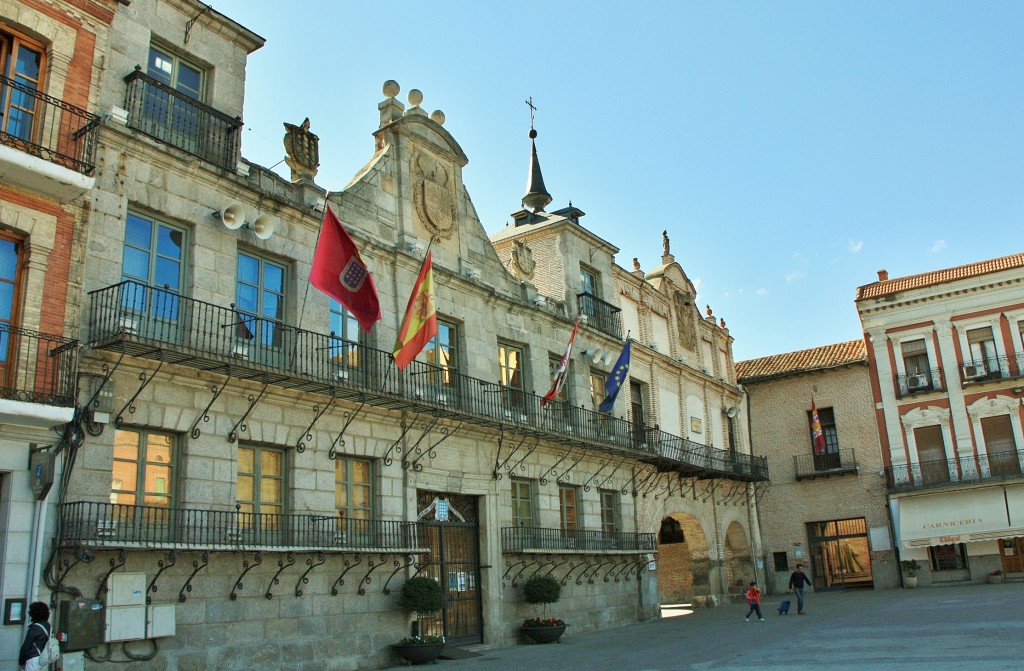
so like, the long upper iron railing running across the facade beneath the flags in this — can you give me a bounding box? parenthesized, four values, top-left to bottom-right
(89, 281, 768, 479)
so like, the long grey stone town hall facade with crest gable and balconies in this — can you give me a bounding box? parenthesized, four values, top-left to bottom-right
(3, 0, 768, 671)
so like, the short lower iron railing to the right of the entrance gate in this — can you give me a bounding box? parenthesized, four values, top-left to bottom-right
(502, 527, 657, 553)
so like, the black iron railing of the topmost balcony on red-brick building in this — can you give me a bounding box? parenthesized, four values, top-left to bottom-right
(0, 72, 99, 175)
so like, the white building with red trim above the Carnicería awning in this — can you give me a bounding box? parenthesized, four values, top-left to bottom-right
(857, 254, 1024, 584)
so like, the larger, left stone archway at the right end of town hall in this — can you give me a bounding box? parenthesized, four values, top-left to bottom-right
(657, 512, 710, 605)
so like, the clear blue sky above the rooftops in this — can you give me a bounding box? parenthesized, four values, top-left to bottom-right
(213, 0, 1024, 361)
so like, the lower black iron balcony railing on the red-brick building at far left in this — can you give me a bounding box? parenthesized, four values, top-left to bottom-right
(0, 324, 78, 408)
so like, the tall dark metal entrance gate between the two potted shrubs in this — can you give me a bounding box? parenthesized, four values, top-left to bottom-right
(416, 490, 483, 645)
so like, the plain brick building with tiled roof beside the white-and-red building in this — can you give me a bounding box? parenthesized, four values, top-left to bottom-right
(736, 340, 898, 594)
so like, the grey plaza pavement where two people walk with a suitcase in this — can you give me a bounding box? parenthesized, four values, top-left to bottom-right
(430, 583, 1024, 671)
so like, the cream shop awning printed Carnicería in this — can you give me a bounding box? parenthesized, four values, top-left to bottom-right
(898, 486, 1024, 549)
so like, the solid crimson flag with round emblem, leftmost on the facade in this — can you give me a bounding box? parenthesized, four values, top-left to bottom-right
(309, 207, 381, 331)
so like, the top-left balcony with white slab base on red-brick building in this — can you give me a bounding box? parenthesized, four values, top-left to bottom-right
(0, 72, 99, 203)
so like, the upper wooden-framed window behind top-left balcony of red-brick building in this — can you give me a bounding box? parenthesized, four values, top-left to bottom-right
(0, 26, 46, 143)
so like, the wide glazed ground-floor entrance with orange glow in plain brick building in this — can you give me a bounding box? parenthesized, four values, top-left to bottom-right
(807, 517, 874, 590)
